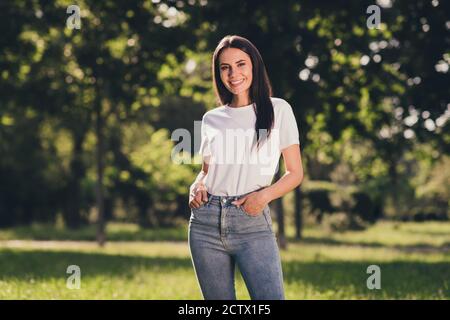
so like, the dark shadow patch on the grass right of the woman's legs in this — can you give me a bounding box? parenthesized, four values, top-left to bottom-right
(283, 261, 450, 299)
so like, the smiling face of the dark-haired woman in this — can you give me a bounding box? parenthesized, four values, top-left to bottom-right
(219, 48, 253, 99)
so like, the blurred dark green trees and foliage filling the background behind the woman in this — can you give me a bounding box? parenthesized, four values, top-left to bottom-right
(0, 0, 450, 243)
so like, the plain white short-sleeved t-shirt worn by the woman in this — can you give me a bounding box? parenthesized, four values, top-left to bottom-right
(199, 97, 300, 196)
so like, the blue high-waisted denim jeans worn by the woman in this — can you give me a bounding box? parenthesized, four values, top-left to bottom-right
(188, 189, 285, 300)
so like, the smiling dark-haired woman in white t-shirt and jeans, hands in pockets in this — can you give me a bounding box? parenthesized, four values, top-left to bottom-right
(189, 35, 303, 300)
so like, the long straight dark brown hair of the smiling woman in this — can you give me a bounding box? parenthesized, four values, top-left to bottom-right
(212, 35, 274, 147)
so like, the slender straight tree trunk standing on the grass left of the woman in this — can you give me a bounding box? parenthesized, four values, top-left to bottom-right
(95, 96, 106, 246)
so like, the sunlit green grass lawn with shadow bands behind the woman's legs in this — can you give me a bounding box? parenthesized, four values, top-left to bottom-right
(0, 222, 450, 299)
